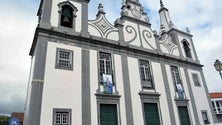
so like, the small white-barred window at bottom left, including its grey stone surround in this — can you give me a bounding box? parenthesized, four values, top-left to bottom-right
(53, 109, 71, 125)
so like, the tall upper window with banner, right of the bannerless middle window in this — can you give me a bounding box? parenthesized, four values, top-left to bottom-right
(171, 66, 186, 99)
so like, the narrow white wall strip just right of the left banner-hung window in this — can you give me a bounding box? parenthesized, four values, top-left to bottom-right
(114, 55, 127, 125)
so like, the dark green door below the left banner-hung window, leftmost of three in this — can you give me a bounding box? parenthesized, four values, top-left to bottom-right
(100, 104, 118, 125)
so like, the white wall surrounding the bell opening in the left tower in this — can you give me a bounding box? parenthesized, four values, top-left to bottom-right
(50, 0, 82, 32)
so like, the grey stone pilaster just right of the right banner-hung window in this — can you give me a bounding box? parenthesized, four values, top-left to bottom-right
(184, 69, 200, 125)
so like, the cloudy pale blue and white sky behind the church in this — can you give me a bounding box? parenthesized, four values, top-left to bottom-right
(0, 0, 222, 114)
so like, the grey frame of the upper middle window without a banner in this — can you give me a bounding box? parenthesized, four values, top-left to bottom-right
(138, 59, 155, 89)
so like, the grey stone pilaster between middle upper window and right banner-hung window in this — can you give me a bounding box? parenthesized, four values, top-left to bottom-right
(160, 61, 176, 125)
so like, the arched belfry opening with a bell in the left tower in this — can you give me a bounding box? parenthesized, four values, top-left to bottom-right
(58, 1, 78, 28)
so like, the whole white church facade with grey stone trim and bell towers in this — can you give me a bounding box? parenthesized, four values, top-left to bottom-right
(24, 0, 216, 125)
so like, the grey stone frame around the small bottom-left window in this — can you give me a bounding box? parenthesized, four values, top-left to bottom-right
(52, 108, 72, 125)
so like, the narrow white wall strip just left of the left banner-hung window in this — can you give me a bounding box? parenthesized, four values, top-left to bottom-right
(90, 50, 99, 125)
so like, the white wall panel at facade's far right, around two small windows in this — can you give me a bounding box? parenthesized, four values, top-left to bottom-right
(188, 70, 213, 124)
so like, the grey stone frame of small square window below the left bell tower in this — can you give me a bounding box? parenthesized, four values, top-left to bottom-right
(55, 48, 74, 70)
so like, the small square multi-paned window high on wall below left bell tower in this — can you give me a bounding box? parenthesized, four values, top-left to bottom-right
(56, 48, 73, 70)
